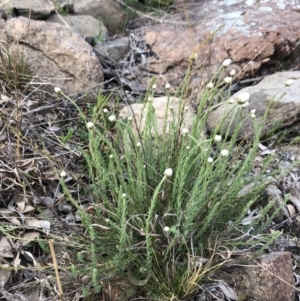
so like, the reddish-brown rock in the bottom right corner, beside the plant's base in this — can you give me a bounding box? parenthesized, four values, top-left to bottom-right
(217, 252, 295, 301)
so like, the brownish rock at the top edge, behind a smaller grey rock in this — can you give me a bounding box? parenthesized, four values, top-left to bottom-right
(71, 0, 127, 35)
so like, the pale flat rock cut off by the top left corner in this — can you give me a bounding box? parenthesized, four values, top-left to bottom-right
(0, 0, 54, 19)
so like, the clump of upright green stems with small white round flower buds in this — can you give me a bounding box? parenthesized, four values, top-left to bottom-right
(56, 55, 290, 300)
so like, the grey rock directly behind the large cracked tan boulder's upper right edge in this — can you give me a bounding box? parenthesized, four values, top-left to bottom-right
(47, 14, 108, 42)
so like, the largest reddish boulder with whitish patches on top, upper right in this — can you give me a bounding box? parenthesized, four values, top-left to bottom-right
(139, 0, 300, 97)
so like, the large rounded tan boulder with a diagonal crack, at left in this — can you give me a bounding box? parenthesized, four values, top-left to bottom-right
(0, 17, 103, 93)
